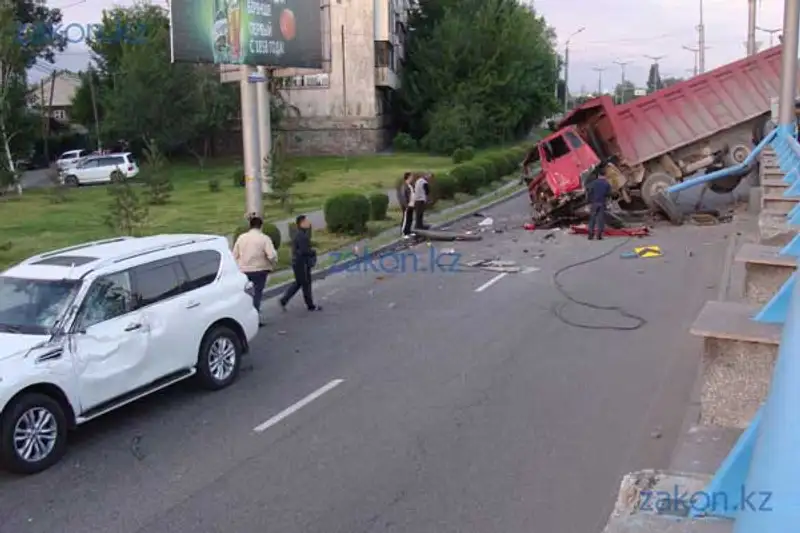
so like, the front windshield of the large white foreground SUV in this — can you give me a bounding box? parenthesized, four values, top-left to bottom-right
(0, 276, 80, 335)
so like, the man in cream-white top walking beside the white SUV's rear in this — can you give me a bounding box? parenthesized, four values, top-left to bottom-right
(233, 216, 278, 313)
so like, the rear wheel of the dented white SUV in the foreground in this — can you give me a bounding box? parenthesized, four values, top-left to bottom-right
(197, 326, 243, 390)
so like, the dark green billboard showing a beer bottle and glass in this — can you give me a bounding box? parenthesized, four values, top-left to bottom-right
(170, 0, 323, 69)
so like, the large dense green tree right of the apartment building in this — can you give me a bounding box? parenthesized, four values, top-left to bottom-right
(395, 0, 558, 155)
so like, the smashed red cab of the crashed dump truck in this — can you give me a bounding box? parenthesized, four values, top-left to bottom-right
(525, 126, 600, 203)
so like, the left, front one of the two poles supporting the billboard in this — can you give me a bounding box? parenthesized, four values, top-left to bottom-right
(239, 65, 264, 217)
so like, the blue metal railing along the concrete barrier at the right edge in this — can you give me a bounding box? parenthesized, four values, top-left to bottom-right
(692, 122, 800, 533)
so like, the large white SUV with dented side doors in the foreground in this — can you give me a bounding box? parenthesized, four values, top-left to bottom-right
(0, 235, 258, 474)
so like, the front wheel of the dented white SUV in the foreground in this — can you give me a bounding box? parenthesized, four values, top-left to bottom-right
(0, 393, 67, 474)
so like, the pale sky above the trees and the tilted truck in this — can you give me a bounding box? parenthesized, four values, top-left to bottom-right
(32, 0, 783, 93)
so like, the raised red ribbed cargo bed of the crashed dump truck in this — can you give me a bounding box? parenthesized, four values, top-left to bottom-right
(559, 46, 800, 165)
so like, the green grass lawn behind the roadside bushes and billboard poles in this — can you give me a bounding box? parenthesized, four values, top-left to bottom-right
(0, 144, 532, 269)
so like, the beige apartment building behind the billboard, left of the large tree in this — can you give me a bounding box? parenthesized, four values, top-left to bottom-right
(221, 0, 411, 155)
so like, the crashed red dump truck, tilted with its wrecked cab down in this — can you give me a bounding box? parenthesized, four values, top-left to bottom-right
(525, 42, 792, 225)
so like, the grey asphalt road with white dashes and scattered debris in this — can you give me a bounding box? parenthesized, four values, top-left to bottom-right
(0, 197, 729, 533)
